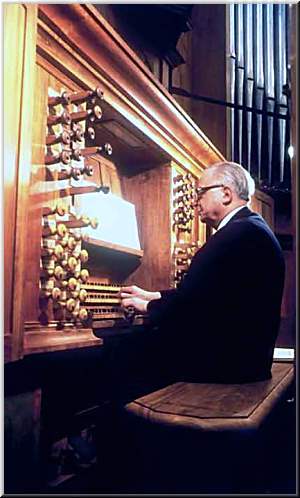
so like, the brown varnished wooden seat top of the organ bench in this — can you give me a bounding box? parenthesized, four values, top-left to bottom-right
(126, 363, 294, 431)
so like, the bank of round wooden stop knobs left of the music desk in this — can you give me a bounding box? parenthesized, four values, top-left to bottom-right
(40, 88, 106, 322)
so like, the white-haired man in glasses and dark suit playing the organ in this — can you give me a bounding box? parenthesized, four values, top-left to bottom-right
(119, 162, 285, 390)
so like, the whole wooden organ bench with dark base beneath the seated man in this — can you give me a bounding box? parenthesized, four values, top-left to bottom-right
(116, 362, 294, 494)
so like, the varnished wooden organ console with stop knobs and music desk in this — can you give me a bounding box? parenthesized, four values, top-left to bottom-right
(4, 3, 223, 361)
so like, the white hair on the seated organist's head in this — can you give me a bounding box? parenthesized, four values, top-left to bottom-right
(209, 161, 255, 201)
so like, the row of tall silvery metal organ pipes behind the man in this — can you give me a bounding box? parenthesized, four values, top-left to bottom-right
(226, 3, 289, 188)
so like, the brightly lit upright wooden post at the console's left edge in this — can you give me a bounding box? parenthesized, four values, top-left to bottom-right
(4, 4, 37, 360)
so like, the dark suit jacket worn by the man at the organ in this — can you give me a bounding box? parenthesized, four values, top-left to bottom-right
(148, 207, 284, 382)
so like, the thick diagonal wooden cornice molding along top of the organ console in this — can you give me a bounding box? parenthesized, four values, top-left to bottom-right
(37, 3, 224, 174)
